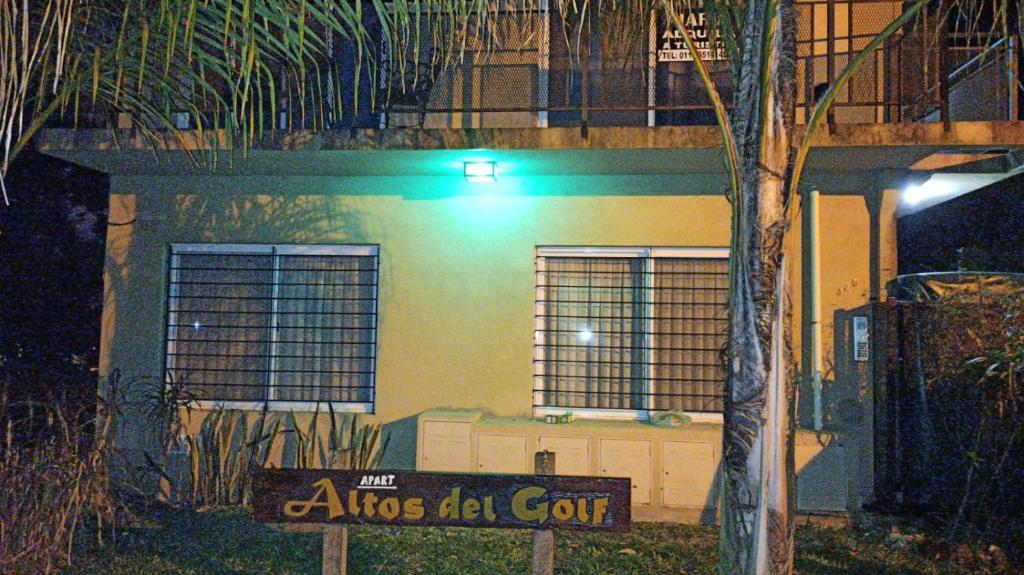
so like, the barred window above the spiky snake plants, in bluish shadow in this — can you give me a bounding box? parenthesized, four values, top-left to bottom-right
(166, 244, 378, 411)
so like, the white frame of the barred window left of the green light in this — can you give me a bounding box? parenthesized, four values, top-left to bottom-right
(163, 242, 380, 413)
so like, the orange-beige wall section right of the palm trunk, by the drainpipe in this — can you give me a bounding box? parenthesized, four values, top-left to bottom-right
(788, 187, 899, 508)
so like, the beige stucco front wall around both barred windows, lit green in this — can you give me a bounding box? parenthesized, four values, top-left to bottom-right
(100, 168, 895, 519)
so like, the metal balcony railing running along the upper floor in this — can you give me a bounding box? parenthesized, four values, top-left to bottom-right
(58, 0, 1021, 129)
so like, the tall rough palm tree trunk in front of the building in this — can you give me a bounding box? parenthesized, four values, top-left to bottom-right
(719, 0, 796, 575)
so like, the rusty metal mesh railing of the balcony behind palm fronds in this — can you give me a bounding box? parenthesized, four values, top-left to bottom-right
(366, 0, 1015, 128)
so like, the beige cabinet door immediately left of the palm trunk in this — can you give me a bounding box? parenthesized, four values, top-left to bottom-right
(662, 441, 718, 507)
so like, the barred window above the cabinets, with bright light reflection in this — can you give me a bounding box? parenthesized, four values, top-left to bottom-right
(534, 248, 729, 418)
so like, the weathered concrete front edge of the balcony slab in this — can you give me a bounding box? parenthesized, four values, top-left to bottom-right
(36, 122, 1024, 152)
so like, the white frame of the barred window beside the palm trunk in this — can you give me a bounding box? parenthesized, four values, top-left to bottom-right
(532, 246, 729, 424)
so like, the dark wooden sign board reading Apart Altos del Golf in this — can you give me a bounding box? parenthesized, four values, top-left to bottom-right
(253, 470, 630, 531)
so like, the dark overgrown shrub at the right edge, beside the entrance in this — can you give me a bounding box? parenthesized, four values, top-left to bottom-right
(901, 294, 1024, 552)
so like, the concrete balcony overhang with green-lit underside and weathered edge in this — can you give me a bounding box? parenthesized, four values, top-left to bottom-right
(36, 122, 1024, 200)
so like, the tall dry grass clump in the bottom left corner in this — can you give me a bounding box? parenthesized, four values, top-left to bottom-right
(0, 368, 121, 573)
